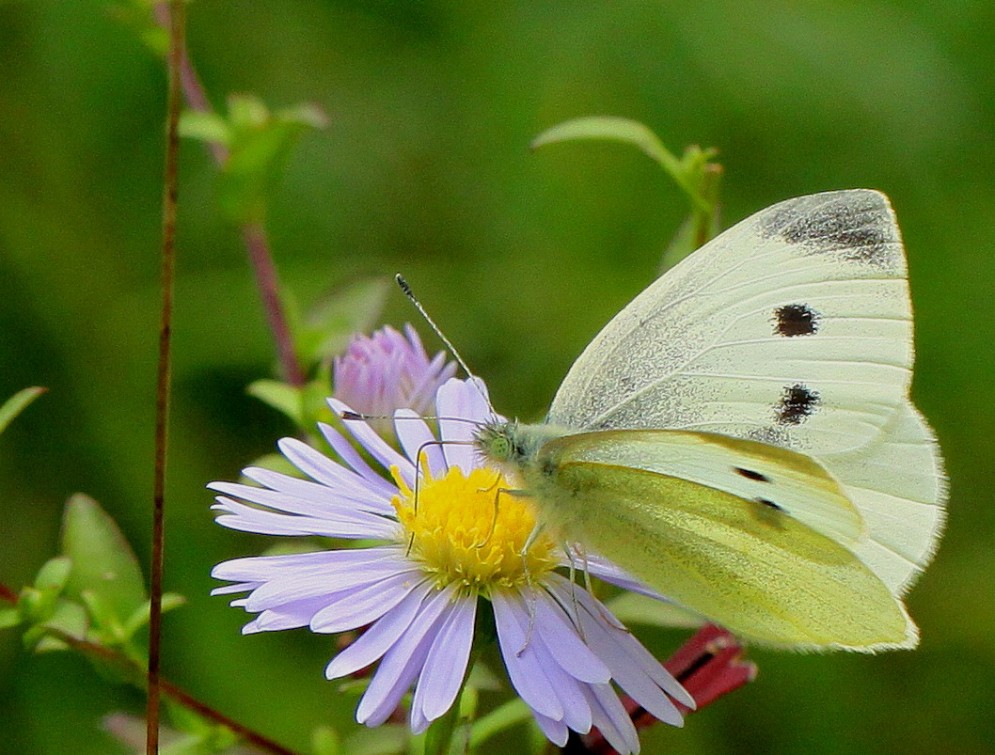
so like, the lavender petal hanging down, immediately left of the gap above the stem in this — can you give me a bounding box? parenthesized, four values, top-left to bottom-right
(411, 596, 477, 721)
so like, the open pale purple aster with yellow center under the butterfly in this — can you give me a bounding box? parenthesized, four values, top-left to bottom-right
(210, 379, 694, 753)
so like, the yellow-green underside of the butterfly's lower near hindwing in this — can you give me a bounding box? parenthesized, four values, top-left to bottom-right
(529, 433, 917, 652)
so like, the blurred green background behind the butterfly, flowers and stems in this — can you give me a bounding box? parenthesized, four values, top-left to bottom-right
(0, 0, 995, 755)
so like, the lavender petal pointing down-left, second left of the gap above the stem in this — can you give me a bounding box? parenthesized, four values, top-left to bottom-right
(356, 586, 456, 726)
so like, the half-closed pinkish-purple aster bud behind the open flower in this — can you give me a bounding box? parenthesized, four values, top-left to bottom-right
(332, 324, 456, 434)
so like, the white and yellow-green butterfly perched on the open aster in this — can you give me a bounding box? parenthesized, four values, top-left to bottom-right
(476, 190, 946, 652)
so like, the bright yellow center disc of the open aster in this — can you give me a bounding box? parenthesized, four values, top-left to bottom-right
(391, 467, 557, 594)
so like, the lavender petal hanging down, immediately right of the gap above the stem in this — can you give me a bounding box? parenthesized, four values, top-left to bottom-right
(490, 590, 563, 720)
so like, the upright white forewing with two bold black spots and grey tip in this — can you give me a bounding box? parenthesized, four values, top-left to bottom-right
(549, 190, 912, 456)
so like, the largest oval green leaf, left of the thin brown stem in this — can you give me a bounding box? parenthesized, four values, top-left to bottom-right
(62, 493, 148, 624)
